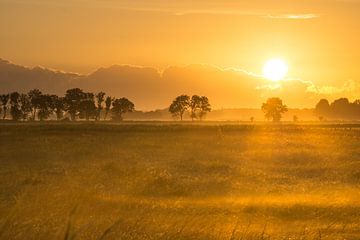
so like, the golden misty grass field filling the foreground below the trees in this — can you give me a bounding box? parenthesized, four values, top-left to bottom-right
(0, 123, 360, 240)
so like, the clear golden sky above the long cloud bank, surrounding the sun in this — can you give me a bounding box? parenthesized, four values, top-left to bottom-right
(0, 0, 360, 108)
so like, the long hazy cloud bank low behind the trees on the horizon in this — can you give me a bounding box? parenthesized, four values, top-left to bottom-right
(0, 60, 360, 110)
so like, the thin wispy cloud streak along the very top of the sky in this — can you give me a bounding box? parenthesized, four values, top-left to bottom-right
(0, 0, 319, 20)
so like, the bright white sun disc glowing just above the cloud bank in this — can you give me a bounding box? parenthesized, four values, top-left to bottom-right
(263, 58, 289, 82)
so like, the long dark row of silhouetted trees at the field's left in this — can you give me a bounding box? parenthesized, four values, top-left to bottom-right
(0, 88, 135, 121)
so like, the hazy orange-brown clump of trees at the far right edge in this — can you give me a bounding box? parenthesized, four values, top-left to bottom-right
(315, 98, 360, 120)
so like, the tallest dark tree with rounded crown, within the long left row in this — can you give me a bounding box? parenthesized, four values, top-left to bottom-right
(64, 88, 86, 121)
